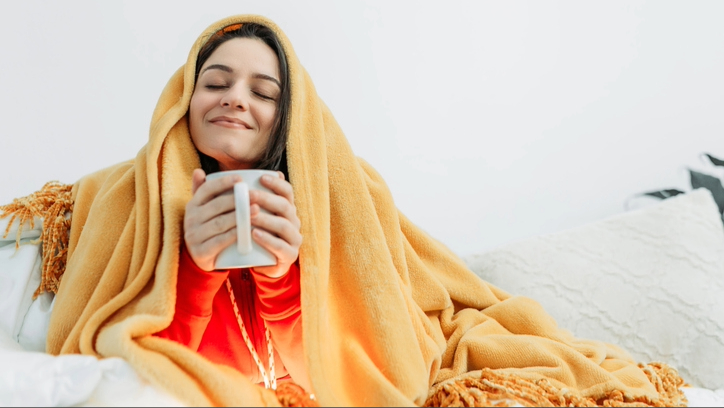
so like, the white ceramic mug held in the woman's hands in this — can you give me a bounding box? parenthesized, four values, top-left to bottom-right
(206, 170, 279, 269)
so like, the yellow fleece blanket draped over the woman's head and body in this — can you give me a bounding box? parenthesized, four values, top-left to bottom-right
(2, 15, 685, 406)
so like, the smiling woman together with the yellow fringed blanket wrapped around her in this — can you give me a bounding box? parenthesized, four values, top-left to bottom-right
(0, 15, 685, 406)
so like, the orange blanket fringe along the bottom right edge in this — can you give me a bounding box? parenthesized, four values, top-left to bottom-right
(424, 363, 688, 407)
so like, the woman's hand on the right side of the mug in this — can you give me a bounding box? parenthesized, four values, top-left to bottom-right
(249, 172, 302, 278)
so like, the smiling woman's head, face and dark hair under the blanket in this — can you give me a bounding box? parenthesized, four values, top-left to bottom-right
(189, 24, 289, 172)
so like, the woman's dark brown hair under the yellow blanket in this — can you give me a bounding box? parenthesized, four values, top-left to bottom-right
(194, 23, 291, 180)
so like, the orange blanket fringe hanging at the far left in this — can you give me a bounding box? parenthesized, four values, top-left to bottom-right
(0, 181, 73, 299)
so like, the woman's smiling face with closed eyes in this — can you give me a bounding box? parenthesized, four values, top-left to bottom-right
(189, 38, 281, 171)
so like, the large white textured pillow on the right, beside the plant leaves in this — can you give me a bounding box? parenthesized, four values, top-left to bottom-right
(465, 189, 724, 389)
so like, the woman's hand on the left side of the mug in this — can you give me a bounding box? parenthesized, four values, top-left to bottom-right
(184, 169, 241, 271)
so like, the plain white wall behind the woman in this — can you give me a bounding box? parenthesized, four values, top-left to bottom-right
(0, 0, 724, 255)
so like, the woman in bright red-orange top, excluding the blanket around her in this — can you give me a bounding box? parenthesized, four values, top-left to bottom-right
(157, 24, 310, 389)
